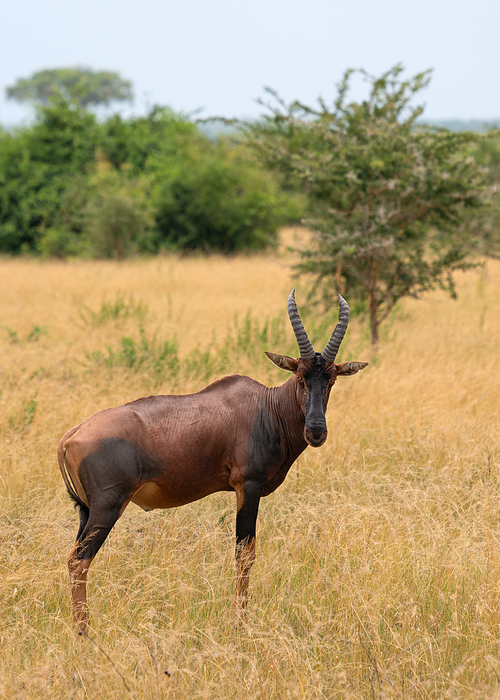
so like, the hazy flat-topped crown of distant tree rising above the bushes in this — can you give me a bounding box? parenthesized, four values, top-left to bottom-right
(6, 68, 132, 108)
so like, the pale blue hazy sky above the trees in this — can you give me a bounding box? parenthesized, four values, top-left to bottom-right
(0, 0, 500, 125)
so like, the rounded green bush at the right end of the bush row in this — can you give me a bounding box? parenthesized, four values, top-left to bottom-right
(148, 141, 300, 253)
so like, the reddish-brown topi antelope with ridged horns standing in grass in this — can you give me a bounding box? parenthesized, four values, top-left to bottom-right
(57, 290, 368, 633)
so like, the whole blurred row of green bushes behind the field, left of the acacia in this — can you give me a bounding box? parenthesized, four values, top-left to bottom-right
(0, 96, 300, 258)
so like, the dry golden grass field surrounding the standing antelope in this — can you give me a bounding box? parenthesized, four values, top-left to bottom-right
(0, 237, 500, 700)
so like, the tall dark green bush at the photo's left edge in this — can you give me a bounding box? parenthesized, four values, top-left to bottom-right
(0, 99, 99, 253)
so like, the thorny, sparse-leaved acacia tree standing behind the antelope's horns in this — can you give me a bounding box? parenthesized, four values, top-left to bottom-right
(249, 65, 482, 344)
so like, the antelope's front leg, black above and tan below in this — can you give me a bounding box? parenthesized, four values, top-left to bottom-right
(234, 481, 263, 620)
